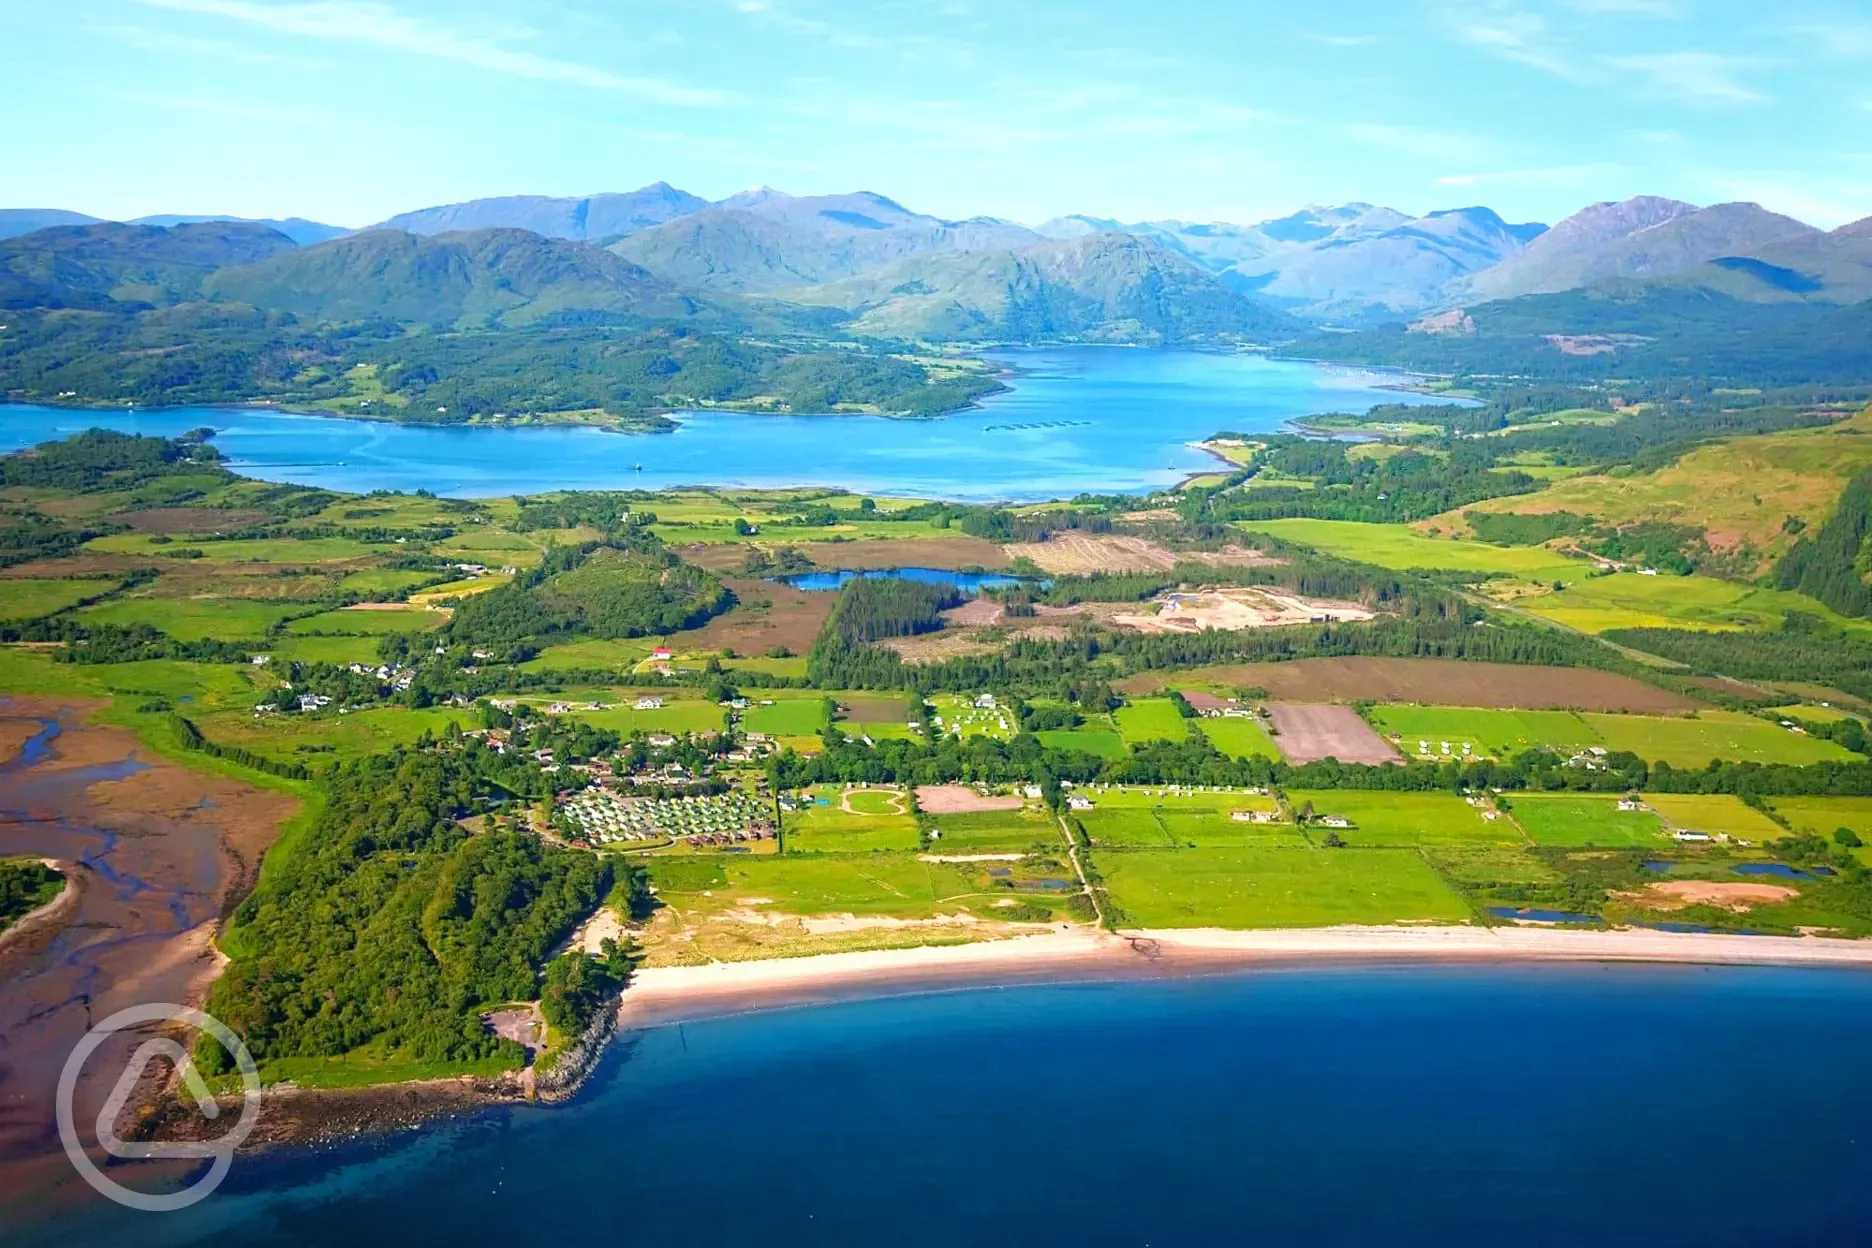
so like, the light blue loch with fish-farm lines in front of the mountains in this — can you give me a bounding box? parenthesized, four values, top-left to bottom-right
(0, 348, 1452, 500)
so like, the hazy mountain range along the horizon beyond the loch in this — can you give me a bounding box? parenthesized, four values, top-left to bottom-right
(0, 183, 1872, 342)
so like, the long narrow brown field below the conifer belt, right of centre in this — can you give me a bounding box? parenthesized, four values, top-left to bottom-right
(1118, 659, 1704, 715)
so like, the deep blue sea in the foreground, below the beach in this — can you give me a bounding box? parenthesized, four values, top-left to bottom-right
(25, 967, 1872, 1248)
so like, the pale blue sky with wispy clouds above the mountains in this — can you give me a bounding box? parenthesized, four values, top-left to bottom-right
(0, 0, 1872, 226)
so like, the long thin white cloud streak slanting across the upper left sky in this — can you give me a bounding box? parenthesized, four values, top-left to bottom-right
(133, 0, 730, 107)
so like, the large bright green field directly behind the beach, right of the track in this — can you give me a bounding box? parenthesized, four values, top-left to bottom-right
(1093, 846, 1470, 928)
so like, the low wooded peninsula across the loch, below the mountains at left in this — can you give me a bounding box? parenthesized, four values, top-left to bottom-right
(0, 305, 1000, 428)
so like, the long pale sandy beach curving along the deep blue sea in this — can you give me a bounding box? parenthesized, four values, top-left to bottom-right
(622, 926, 1872, 1027)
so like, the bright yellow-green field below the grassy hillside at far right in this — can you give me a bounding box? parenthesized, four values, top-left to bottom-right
(1518, 573, 1872, 632)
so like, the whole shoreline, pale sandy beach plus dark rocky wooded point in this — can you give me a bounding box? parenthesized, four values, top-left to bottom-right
(135, 924, 1872, 1153)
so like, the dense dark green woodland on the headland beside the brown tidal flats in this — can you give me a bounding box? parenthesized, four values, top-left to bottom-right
(208, 747, 616, 1065)
